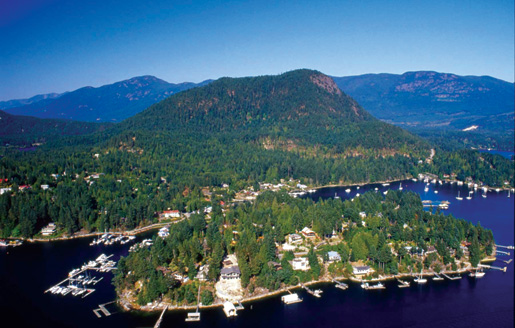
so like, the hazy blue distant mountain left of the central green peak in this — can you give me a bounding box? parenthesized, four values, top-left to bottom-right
(6, 76, 210, 122)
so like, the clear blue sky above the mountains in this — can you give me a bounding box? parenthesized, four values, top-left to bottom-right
(0, 0, 515, 101)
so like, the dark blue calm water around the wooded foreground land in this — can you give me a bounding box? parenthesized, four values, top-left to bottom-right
(0, 181, 515, 328)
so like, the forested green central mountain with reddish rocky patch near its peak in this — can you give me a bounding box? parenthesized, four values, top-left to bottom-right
(117, 70, 430, 153)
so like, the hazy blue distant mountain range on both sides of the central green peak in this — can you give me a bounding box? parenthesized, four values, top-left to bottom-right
(0, 71, 515, 132)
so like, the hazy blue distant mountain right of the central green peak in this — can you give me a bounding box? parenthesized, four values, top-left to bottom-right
(333, 71, 514, 131)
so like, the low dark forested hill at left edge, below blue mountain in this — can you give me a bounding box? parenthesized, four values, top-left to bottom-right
(0, 110, 112, 146)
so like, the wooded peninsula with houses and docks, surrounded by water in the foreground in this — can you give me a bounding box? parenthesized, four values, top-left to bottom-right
(113, 191, 495, 311)
